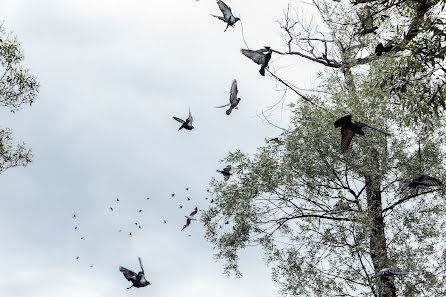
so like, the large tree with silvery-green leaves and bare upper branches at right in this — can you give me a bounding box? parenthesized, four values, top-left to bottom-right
(202, 0, 446, 297)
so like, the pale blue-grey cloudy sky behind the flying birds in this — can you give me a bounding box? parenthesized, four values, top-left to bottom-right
(0, 0, 317, 297)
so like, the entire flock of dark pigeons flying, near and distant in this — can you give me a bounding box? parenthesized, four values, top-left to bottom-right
(74, 0, 442, 289)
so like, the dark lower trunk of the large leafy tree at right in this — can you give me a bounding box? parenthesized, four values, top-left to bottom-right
(365, 176, 396, 297)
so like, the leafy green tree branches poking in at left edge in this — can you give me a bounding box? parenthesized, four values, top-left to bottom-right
(0, 24, 39, 173)
